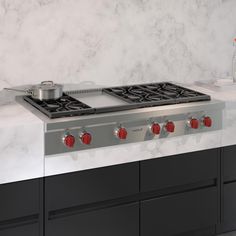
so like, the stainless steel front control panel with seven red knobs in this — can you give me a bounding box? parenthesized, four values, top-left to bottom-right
(45, 101, 224, 155)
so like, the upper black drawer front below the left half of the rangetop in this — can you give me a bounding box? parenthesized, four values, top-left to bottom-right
(45, 163, 139, 211)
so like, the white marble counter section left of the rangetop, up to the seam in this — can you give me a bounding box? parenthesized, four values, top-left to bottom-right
(0, 102, 44, 184)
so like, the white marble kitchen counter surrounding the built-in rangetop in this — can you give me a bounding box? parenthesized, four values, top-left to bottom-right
(0, 85, 236, 183)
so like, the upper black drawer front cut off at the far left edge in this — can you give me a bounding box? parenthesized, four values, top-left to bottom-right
(0, 179, 39, 221)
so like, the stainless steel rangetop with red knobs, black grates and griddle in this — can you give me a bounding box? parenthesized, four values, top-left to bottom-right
(17, 83, 224, 155)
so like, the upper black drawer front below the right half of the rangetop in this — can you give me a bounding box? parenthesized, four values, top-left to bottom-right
(141, 149, 219, 191)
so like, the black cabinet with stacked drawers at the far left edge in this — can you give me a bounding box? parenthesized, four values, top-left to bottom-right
(0, 179, 42, 236)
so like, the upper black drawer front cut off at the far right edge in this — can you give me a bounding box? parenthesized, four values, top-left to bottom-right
(223, 145, 236, 182)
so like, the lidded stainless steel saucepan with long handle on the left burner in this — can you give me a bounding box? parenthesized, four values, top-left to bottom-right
(4, 81, 63, 101)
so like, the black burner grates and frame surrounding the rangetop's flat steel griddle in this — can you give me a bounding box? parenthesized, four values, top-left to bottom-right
(24, 82, 211, 118)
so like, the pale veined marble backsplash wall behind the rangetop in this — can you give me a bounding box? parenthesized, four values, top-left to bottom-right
(0, 0, 236, 90)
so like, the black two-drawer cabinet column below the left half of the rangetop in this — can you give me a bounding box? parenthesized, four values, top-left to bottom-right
(45, 162, 139, 236)
